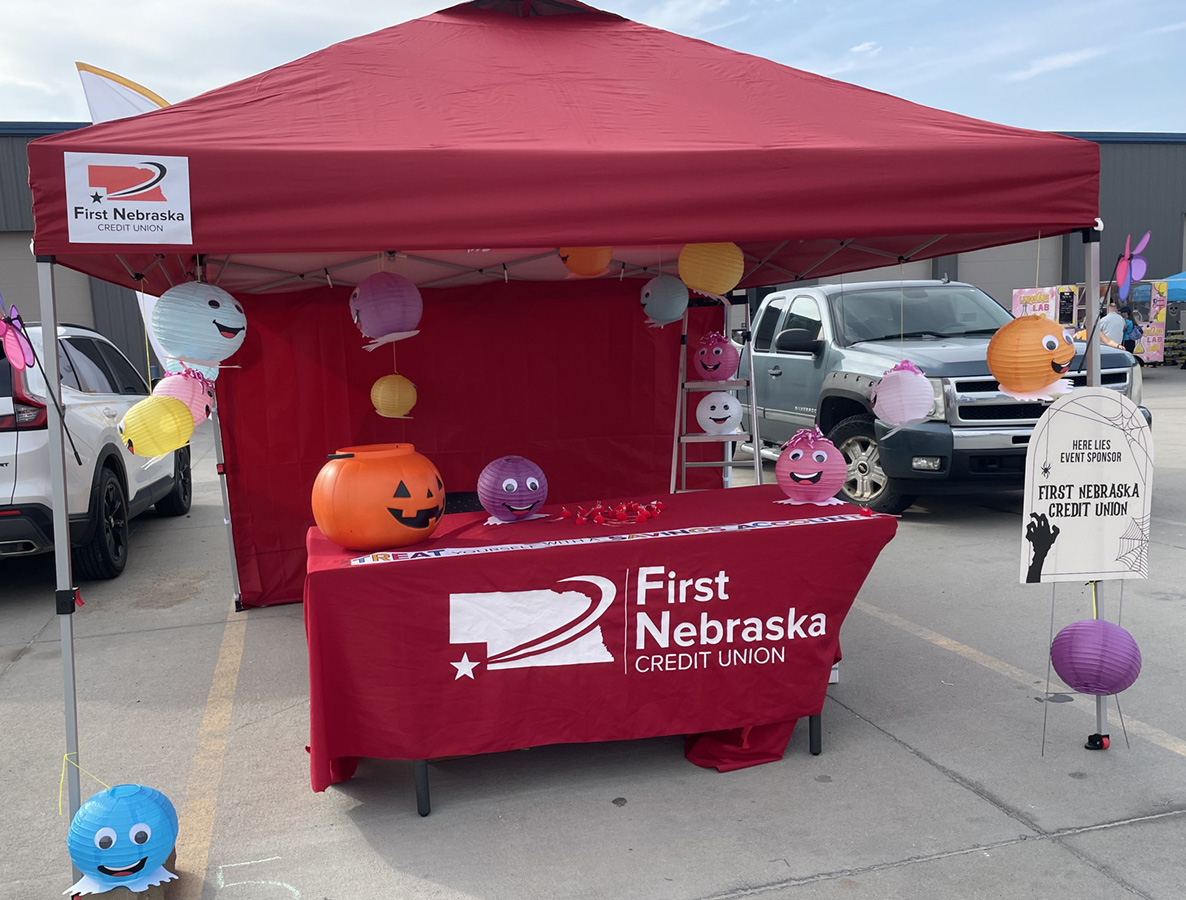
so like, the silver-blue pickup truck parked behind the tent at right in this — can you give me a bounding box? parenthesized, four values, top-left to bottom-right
(739, 281, 1152, 512)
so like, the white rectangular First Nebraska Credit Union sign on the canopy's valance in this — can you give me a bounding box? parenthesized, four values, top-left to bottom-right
(63, 153, 193, 244)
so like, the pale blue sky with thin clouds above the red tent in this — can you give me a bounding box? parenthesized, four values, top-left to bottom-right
(0, 0, 1186, 133)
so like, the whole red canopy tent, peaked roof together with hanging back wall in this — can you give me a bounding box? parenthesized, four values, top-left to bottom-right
(28, 0, 1099, 605)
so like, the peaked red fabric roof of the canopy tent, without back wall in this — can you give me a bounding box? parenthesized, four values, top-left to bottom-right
(30, 0, 1099, 291)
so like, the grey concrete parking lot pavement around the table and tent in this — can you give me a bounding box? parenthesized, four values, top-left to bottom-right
(0, 366, 1186, 900)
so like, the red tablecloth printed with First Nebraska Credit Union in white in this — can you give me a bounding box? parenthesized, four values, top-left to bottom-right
(305, 485, 897, 791)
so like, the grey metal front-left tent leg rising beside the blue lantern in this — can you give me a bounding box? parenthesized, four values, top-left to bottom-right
(37, 256, 82, 881)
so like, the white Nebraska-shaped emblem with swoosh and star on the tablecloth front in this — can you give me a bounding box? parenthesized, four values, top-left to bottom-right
(449, 575, 618, 679)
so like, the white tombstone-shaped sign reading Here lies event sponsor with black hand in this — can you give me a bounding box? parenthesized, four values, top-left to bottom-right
(1021, 388, 1153, 583)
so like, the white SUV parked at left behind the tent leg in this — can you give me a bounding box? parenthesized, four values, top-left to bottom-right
(0, 325, 192, 580)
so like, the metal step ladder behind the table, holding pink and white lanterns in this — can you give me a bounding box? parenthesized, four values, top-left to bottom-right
(670, 298, 763, 493)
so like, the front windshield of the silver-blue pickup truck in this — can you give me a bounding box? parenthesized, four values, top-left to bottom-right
(833, 285, 1013, 344)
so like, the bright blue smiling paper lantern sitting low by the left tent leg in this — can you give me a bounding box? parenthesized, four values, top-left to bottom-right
(66, 784, 177, 894)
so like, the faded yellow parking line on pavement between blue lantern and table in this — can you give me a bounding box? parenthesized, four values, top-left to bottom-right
(170, 611, 247, 900)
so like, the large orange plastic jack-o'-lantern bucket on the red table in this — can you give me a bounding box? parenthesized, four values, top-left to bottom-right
(313, 443, 445, 551)
